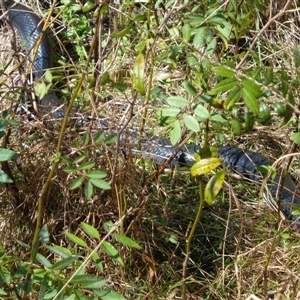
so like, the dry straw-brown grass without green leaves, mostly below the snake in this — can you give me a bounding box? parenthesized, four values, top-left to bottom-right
(0, 0, 300, 300)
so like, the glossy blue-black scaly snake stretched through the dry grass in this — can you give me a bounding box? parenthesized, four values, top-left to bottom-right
(6, 0, 300, 230)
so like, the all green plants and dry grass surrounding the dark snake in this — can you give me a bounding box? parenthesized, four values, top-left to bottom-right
(0, 0, 300, 300)
